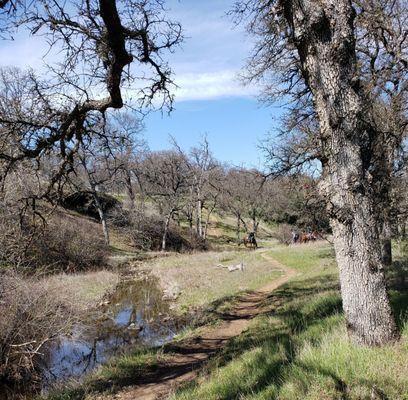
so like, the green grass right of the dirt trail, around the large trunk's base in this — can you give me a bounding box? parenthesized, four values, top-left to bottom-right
(172, 244, 408, 400)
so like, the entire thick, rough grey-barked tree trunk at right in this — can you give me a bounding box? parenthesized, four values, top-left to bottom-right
(284, 0, 396, 345)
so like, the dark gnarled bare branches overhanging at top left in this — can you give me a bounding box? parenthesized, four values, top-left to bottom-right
(0, 0, 181, 205)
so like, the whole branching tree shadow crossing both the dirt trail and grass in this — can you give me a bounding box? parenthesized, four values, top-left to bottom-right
(51, 255, 408, 400)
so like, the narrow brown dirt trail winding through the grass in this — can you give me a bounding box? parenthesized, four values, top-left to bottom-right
(96, 249, 296, 400)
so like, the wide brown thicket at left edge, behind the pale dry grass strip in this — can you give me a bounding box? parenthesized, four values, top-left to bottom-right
(0, 211, 107, 271)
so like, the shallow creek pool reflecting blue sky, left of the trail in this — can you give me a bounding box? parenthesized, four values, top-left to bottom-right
(43, 277, 177, 389)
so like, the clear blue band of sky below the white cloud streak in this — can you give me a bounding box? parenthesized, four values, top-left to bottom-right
(145, 96, 279, 168)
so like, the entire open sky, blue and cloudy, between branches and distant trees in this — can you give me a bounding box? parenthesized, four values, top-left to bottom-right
(0, 0, 280, 167)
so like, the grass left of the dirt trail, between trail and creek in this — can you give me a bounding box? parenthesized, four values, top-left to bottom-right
(39, 244, 282, 400)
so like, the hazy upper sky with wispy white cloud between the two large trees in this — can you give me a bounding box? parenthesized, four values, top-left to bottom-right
(165, 0, 257, 102)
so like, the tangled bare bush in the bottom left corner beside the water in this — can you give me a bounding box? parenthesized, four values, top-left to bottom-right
(0, 271, 75, 390)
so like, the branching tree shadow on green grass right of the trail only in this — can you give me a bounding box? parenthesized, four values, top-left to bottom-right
(175, 267, 408, 400)
